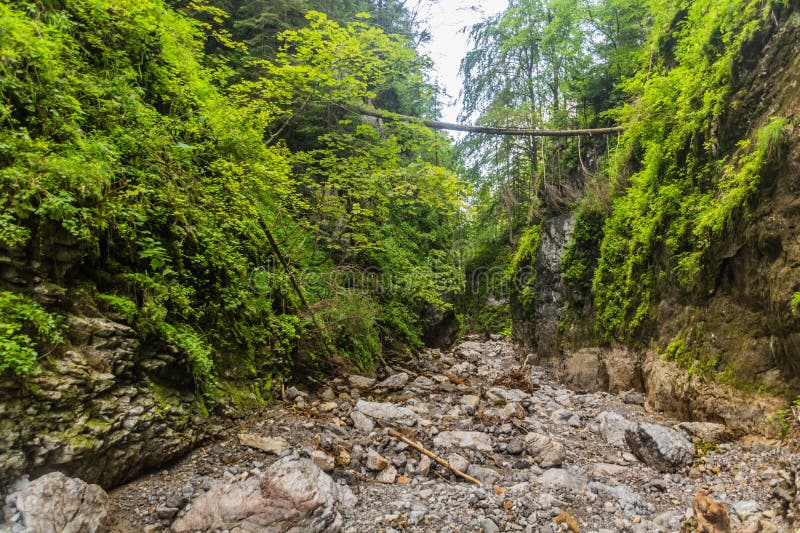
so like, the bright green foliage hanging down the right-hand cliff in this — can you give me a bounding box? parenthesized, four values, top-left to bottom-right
(593, 0, 785, 341)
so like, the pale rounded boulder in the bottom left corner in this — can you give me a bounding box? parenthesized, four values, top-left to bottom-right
(16, 472, 108, 533)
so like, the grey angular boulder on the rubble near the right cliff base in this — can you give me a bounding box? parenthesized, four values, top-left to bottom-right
(625, 423, 695, 472)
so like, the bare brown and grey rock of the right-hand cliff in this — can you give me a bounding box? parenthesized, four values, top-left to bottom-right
(514, 6, 800, 431)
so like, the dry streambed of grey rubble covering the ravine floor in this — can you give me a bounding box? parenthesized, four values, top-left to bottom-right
(111, 340, 800, 533)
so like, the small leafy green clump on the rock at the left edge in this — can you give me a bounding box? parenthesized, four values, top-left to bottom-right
(0, 291, 64, 376)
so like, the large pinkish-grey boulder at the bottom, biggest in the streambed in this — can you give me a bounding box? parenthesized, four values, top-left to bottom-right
(172, 457, 342, 533)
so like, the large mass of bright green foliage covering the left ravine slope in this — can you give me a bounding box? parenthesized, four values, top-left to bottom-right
(0, 0, 464, 392)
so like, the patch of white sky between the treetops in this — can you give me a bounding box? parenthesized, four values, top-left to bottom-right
(420, 0, 508, 122)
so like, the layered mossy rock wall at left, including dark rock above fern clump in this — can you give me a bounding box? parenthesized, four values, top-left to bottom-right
(0, 224, 210, 487)
